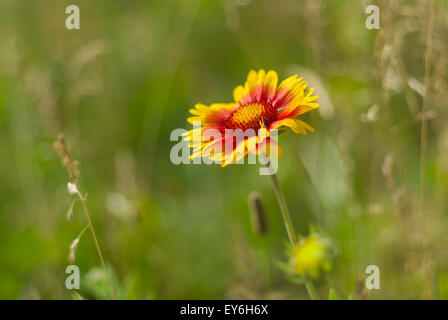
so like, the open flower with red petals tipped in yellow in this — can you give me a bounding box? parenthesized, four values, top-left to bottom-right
(184, 70, 319, 166)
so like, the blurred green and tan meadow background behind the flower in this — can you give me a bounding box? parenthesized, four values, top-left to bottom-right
(0, 0, 448, 299)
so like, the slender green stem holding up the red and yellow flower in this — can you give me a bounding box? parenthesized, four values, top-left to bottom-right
(271, 172, 319, 300)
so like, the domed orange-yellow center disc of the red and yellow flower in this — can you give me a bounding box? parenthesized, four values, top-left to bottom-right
(225, 103, 276, 131)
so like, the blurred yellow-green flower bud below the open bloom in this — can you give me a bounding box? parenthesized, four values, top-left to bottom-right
(291, 234, 332, 278)
